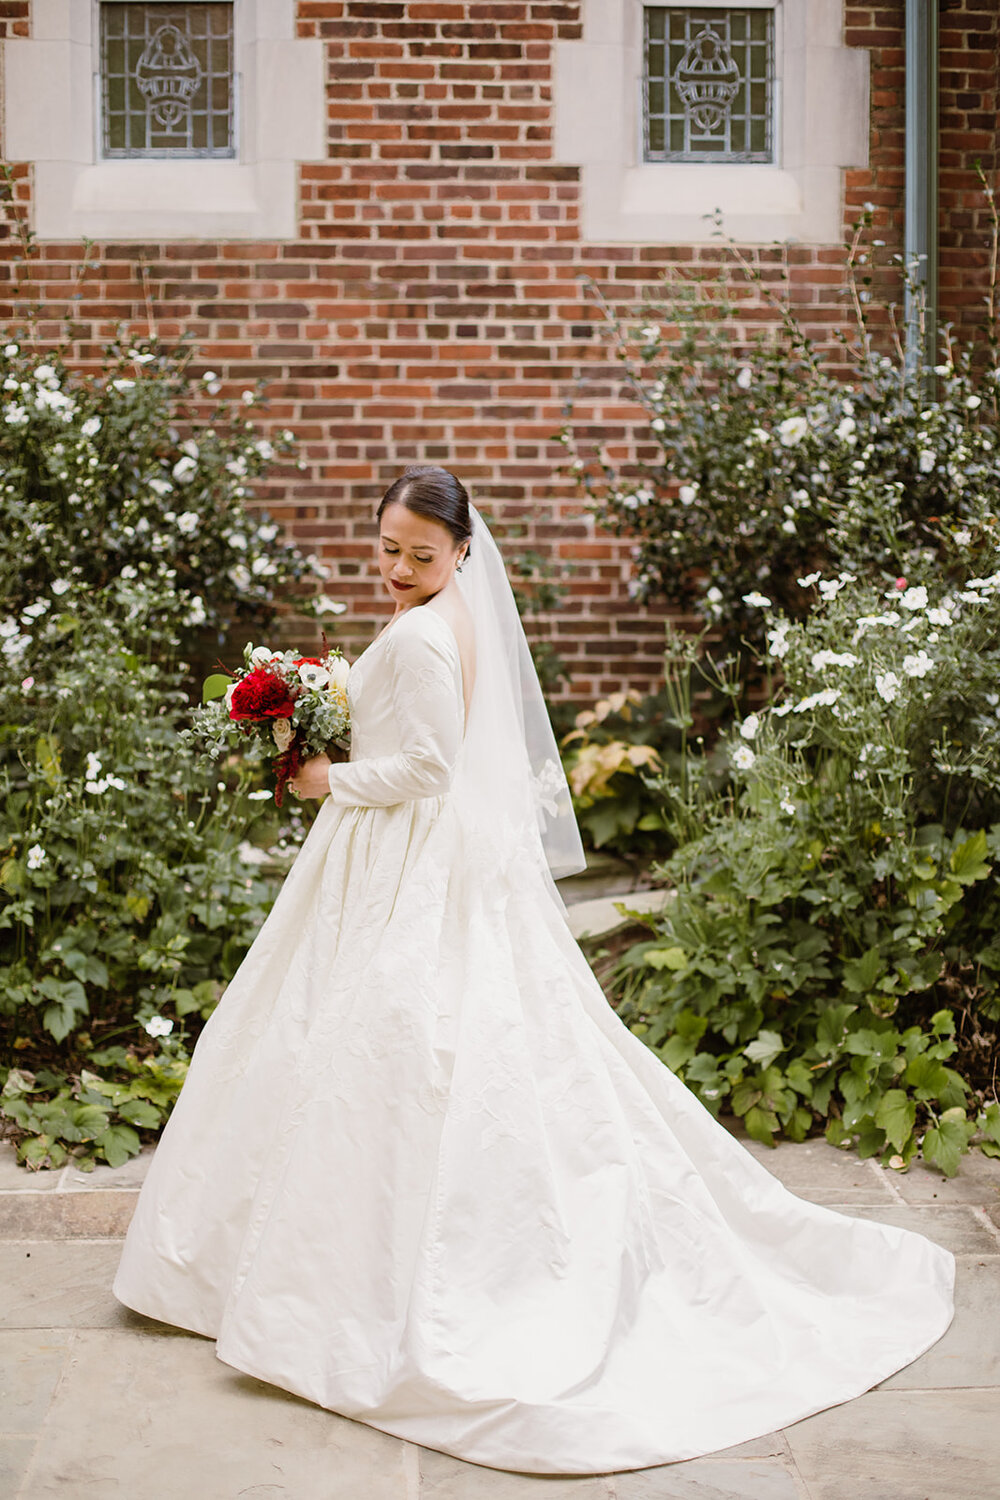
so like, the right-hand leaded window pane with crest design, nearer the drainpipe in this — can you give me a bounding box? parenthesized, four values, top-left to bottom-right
(643, 6, 774, 162)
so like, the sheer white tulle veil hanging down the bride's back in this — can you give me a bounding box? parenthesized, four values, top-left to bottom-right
(453, 509, 586, 881)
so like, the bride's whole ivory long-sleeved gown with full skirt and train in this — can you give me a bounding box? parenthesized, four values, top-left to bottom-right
(114, 606, 954, 1473)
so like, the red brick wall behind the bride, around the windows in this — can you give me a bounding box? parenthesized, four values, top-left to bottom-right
(0, 0, 997, 698)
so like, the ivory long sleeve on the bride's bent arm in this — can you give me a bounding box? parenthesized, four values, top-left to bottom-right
(330, 608, 463, 807)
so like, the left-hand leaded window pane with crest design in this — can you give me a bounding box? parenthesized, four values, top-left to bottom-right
(100, 0, 235, 158)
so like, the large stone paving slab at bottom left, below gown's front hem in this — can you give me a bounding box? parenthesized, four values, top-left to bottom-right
(11, 1328, 412, 1500)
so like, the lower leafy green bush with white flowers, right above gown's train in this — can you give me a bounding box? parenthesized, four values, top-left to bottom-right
(622, 573, 1000, 1173)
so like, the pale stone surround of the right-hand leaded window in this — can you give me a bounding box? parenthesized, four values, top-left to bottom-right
(553, 0, 870, 245)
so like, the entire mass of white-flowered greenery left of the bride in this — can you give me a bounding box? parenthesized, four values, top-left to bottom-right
(0, 341, 332, 1167)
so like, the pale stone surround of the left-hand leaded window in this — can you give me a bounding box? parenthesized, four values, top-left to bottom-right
(3, 0, 327, 240)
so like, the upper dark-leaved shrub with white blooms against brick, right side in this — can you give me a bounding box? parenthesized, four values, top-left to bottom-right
(561, 216, 1000, 645)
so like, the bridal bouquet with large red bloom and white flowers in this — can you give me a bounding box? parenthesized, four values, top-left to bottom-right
(192, 645, 349, 807)
